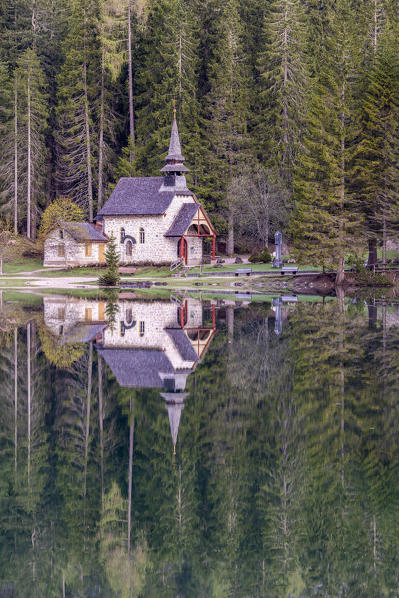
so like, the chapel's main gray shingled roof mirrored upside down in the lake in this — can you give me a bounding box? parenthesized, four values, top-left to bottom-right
(98, 349, 174, 388)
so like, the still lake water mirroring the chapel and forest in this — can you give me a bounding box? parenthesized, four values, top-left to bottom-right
(0, 293, 399, 598)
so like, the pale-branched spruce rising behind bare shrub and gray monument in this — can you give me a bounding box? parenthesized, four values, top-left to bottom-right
(256, 0, 308, 188)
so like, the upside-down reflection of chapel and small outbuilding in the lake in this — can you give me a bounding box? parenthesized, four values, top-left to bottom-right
(44, 296, 215, 452)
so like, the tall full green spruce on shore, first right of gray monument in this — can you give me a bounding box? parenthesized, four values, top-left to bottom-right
(291, 0, 360, 284)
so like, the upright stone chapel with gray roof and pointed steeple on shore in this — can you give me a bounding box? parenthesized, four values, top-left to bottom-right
(96, 117, 216, 265)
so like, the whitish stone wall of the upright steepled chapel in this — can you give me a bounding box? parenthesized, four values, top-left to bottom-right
(104, 195, 202, 265)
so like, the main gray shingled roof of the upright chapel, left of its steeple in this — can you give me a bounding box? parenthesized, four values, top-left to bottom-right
(97, 177, 175, 218)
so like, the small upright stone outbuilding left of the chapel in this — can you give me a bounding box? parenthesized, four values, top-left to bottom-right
(44, 222, 108, 267)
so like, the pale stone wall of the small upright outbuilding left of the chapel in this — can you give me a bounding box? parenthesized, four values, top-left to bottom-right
(43, 228, 104, 267)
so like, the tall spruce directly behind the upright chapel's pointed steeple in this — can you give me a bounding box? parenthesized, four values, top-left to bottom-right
(135, 0, 200, 181)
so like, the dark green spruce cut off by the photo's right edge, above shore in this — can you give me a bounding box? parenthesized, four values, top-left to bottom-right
(353, 31, 399, 264)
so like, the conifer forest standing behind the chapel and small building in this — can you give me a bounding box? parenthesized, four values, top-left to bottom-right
(0, 0, 399, 268)
